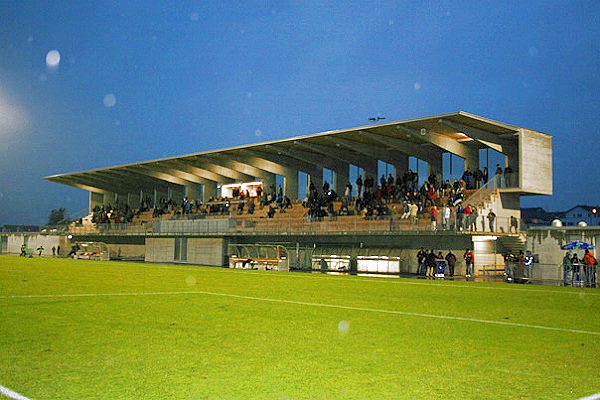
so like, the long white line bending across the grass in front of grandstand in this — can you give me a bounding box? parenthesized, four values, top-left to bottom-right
(0, 290, 600, 336)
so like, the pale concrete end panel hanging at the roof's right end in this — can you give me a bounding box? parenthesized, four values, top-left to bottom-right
(519, 129, 552, 194)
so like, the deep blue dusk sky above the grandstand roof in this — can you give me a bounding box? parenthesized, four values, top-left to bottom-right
(0, 0, 600, 225)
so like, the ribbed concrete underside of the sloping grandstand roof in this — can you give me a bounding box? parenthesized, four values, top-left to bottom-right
(45, 111, 540, 193)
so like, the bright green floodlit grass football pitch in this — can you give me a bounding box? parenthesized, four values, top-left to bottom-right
(0, 256, 600, 399)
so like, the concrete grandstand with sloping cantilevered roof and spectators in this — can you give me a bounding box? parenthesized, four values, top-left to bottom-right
(36, 111, 552, 274)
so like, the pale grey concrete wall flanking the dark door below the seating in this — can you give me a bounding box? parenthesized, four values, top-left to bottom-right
(145, 237, 224, 266)
